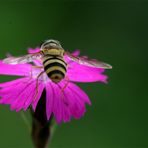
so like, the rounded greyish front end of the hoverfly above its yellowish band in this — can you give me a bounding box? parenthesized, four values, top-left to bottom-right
(41, 39, 62, 49)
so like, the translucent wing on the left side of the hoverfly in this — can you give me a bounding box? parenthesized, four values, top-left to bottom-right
(3, 52, 42, 64)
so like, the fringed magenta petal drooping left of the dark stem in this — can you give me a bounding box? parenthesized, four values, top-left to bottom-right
(0, 78, 44, 111)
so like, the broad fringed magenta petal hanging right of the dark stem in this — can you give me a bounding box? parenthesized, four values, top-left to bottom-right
(46, 81, 91, 123)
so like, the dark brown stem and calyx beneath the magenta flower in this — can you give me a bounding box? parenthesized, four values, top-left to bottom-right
(31, 90, 52, 148)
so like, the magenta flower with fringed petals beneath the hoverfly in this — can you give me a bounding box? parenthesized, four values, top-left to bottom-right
(0, 48, 107, 123)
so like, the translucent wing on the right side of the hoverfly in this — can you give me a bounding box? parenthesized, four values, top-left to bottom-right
(65, 52, 112, 69)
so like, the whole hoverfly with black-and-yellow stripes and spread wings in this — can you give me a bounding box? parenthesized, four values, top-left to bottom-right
(3, 39, 112, 83)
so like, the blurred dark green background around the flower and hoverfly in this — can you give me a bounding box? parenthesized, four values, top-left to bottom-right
(0, 0, 148, 148)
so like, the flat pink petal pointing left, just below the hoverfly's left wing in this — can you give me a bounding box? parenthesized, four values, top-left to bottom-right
(0, 61, 32, 76)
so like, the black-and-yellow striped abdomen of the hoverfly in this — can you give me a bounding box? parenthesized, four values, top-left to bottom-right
(43, 55, 67, 83)
